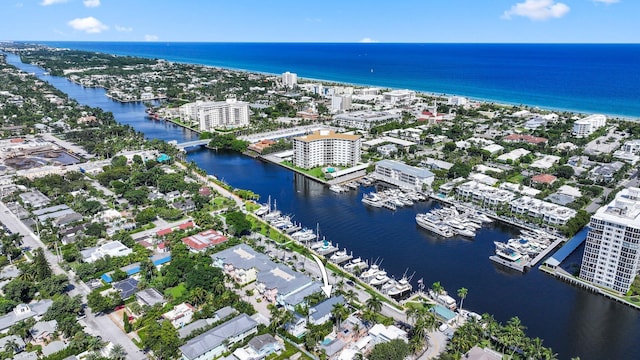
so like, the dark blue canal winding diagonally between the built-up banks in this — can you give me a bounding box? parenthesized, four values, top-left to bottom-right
(7, 55, 640, 360)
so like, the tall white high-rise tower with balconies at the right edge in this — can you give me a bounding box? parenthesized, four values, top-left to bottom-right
(580, 188, 640, 294)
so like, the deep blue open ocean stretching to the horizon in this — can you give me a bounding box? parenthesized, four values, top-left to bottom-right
(43, 42, 640, 119)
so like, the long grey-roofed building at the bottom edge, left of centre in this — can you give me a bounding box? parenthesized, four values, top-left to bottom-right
(180, 314, 258, 360)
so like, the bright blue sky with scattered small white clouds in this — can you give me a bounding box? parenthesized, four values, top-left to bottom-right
(0, 0, 640, 43)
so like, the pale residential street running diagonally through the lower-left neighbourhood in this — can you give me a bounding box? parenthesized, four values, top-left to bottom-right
(0, 201, 146, 360)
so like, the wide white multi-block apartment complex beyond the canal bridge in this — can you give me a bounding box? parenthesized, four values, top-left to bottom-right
(180, 99, 249, 131)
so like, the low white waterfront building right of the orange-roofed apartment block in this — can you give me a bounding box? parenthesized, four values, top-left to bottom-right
(373, 160, 435, 191)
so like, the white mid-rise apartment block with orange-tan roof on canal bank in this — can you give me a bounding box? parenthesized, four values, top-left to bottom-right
(293, 130, 362, 169)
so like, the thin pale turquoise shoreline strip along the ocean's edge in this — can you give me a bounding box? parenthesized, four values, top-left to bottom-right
(28, 42, 640, 121)
